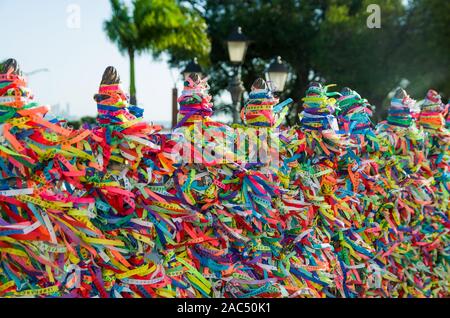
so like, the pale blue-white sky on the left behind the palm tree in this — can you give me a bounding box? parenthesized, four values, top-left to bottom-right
(0, 0, 182, 122)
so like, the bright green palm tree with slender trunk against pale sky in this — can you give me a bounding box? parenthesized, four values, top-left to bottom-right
(104, 0, 210, 105)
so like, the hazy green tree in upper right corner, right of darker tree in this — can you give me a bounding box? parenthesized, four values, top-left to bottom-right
(315, 0, 450, 120)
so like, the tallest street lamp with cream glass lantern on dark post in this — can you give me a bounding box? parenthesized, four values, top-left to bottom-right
(227, 27, 250, 123)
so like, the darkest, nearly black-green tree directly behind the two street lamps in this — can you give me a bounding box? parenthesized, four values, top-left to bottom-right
(193, 0, 326, 121)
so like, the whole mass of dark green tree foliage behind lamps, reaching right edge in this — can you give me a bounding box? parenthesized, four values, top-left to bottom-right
(185, 0, 450, 123)
